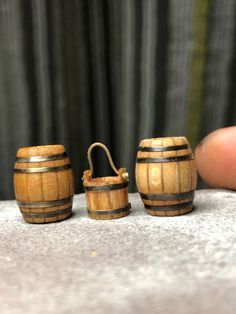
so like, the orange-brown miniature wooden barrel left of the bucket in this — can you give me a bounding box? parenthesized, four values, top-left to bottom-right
(14, 145, 74, 223)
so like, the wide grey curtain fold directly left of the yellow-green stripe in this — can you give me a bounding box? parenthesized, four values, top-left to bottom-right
(165, 0, 195, 135)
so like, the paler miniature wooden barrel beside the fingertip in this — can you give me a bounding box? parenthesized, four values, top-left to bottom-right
(135, 137, 197, 216)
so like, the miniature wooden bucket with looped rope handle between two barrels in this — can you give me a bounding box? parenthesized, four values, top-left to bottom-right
(83, 143, 130, 219)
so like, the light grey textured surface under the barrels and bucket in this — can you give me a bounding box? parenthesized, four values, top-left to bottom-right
(0, 190, 236, 314)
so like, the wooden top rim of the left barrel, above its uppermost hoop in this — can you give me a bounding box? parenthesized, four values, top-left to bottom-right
(17, 144, 65, 157)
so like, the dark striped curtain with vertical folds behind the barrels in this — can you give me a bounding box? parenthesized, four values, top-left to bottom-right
(0, 0, 236, 199)
